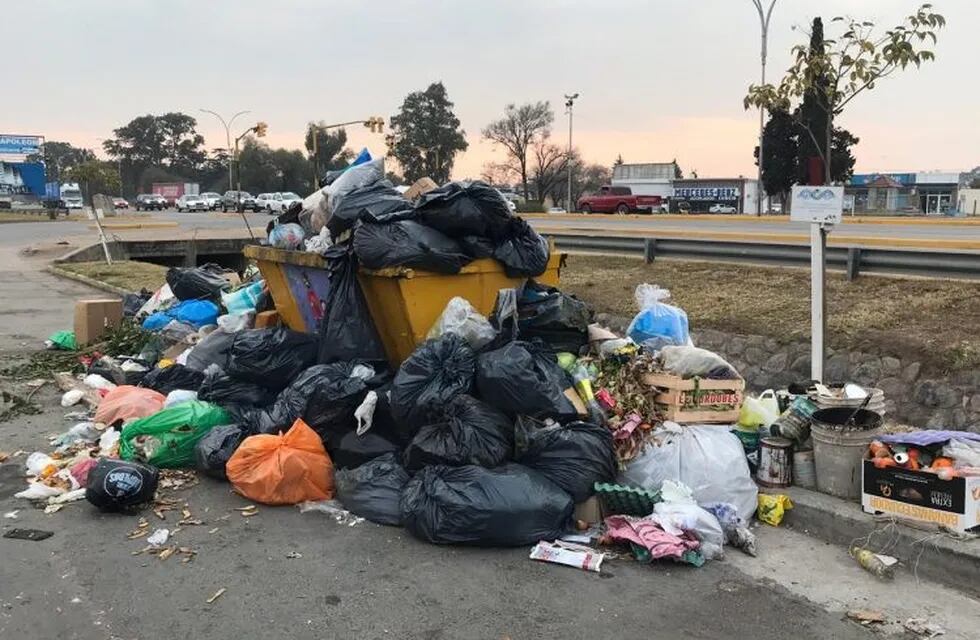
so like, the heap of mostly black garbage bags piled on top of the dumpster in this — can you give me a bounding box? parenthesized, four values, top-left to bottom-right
(267, 150, 550, 277)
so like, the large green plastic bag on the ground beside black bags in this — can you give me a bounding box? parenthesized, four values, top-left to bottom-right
(119, 400, 232, 468)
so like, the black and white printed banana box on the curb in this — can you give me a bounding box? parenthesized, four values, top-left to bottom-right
(861, 460, 980, 532)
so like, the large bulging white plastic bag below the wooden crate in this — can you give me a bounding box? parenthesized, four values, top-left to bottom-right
(619, 422, 759, 521)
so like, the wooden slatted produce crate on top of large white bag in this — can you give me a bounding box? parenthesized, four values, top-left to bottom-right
(641, 373, 745, 424)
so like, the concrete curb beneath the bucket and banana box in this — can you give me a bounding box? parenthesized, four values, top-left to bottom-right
(765, 487, 980, 597)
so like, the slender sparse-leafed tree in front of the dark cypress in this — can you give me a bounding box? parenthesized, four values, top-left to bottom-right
(743, 4, 946, 182)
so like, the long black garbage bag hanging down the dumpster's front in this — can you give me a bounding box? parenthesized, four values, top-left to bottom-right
(317, 245, 386, 364)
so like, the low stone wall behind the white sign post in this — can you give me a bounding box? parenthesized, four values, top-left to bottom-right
(596, 314, 980, 433)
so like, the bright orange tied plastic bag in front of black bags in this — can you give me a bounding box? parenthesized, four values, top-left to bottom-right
(225, 419, 334, 504)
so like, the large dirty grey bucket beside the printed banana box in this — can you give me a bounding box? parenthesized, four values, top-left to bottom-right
(811, 408, 881, 499)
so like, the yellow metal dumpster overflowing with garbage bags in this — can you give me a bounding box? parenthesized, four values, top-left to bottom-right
(244, 245, 563, 367)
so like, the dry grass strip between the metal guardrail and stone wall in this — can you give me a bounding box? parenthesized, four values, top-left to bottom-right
(561, 255, 980, 373)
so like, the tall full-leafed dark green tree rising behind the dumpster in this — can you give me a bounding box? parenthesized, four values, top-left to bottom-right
(388, 82, 469, 184)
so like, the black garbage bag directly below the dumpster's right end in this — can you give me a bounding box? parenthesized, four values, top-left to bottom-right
(517, 280, 591, 355)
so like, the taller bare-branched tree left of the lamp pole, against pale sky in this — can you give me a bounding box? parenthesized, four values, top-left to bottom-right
(483, 102, 555, 198)
